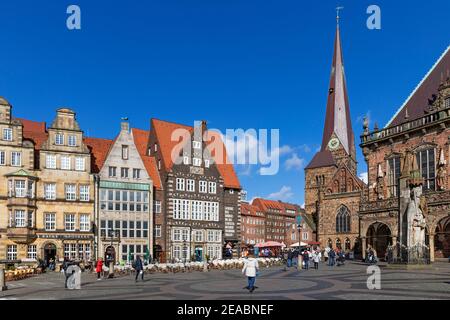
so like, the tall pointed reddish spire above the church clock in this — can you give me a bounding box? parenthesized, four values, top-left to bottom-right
(321, 13, 355, 155)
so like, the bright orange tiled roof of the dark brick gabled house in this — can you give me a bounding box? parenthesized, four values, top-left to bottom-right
(151, 119, 241, 189)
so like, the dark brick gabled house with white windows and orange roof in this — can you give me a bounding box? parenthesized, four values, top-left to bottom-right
(147, 119, 241, 261)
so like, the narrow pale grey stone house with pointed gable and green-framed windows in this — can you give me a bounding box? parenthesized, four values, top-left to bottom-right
(92, 121, 153, 262)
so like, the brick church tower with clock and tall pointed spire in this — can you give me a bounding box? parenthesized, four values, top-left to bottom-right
(305, 14, 363, 248)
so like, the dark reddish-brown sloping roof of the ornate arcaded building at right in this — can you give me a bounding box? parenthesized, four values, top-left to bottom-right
(386, 46, 450, 127)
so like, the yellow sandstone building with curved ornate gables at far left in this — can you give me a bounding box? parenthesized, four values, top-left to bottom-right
(0, 103, 94, 262)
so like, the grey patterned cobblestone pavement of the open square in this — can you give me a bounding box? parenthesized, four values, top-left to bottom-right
(0, 262, 450, 300)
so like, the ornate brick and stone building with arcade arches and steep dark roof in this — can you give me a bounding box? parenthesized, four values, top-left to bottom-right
(360, 47, 450, 261)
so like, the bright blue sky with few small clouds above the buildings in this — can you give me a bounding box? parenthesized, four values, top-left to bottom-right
(0, 0, 450, 204)
